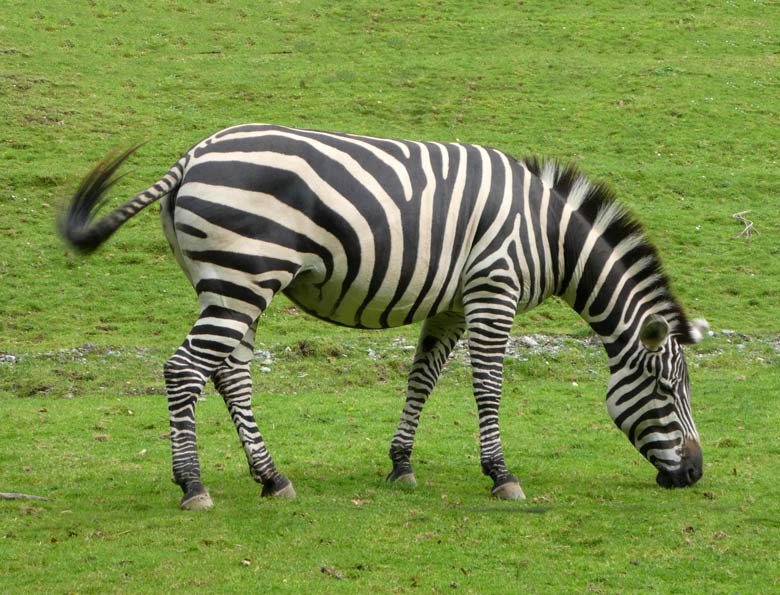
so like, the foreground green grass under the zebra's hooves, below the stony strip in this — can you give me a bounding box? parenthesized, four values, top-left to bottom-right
(0, 339, 780, 593)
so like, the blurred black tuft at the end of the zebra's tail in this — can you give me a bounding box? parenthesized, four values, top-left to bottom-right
(57, 145, 140, 254)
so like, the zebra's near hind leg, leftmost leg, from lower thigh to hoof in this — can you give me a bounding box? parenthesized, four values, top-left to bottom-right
(164, 306, 259, 510)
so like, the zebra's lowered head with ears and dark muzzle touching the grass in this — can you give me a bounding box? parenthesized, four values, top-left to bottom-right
(607, 314, 707, 488)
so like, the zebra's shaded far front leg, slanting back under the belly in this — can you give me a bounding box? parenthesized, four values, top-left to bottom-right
(387, 312, 465, 485)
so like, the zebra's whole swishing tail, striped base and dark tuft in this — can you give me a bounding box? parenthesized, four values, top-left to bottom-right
(57, 145, 182, 254)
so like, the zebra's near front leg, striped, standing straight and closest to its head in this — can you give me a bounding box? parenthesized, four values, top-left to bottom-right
(467, 302, 525, 500)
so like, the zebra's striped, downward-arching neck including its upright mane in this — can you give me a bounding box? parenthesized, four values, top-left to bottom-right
(521, 159, 691, 366)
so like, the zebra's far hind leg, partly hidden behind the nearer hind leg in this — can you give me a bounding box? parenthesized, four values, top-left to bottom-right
(213, 321, 295, 498)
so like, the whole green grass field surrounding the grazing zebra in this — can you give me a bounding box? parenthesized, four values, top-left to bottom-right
(0, 0, 780, 594)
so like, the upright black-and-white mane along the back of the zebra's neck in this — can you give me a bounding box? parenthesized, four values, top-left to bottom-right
(522, 157, 701, 343)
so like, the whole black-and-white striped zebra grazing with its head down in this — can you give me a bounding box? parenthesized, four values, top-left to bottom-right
(59, 124, 704, 509)
